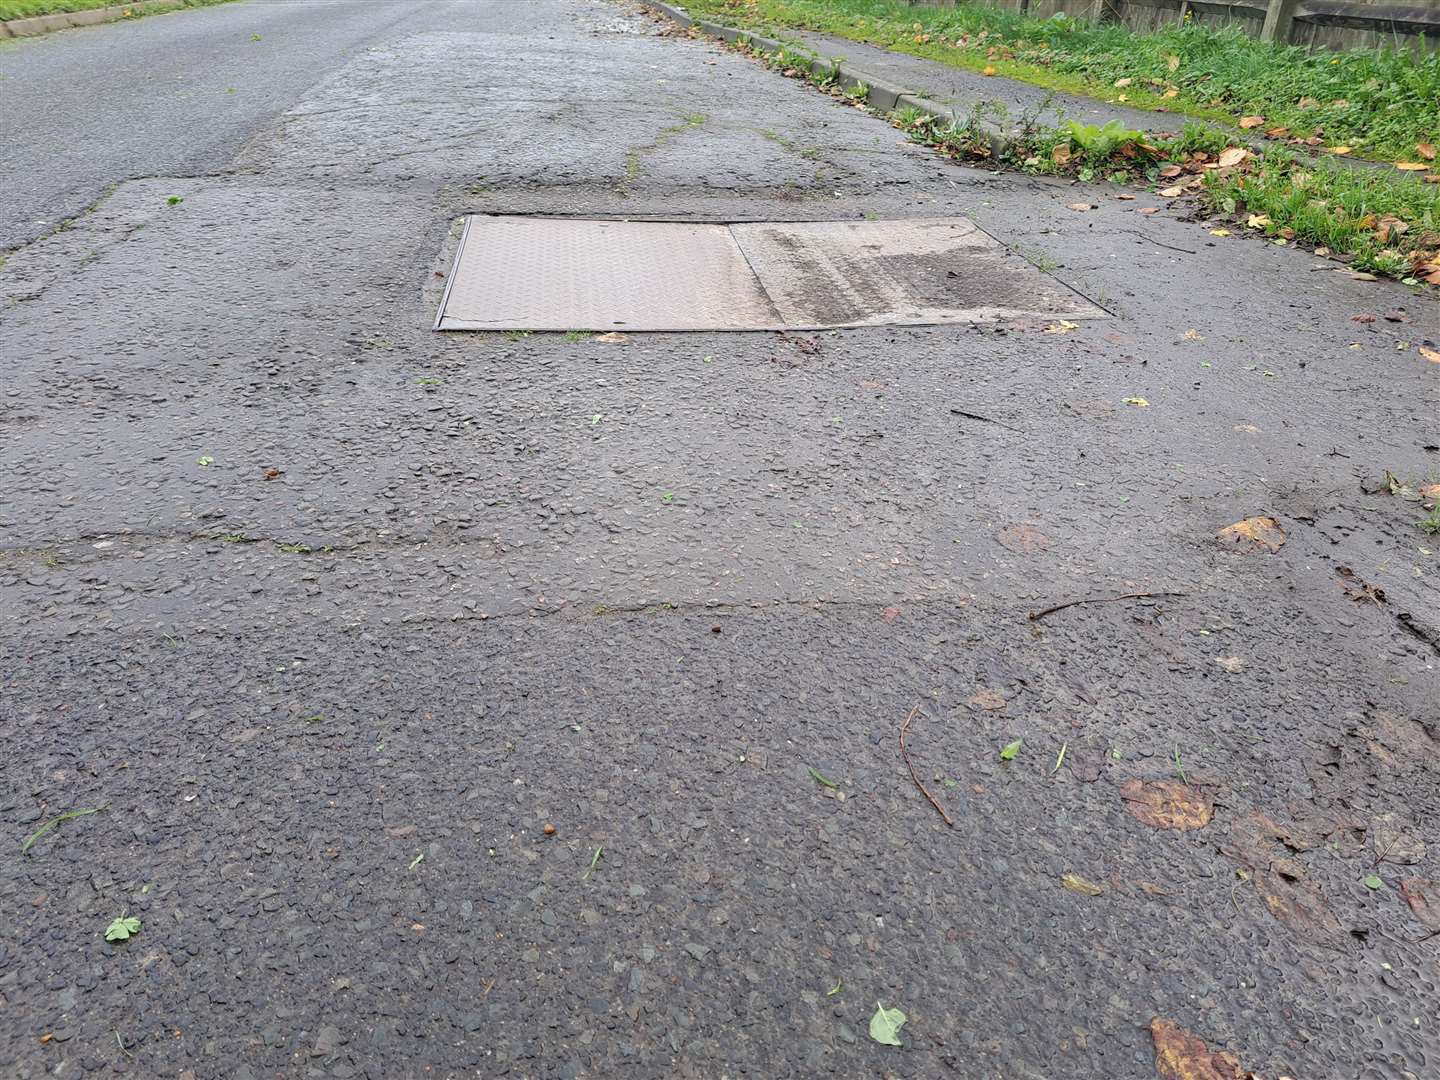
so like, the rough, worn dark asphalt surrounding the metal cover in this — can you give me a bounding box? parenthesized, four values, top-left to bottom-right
(0, 0, 1440, 1080)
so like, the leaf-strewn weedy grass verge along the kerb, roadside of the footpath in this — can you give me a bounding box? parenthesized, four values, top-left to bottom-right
(733, 37, 1440, 287)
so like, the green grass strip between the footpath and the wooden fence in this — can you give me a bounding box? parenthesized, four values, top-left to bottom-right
(687, 0, 1440, 161)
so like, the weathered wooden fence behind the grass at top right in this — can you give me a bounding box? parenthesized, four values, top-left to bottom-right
(907, 0, 1440, 52)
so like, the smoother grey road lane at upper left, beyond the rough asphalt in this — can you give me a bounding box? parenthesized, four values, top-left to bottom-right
(0, 0, 475, 251)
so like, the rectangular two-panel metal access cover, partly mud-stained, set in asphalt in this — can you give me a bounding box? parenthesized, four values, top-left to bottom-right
(435, 215, 1106, 331)
